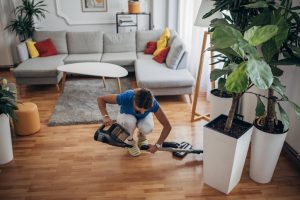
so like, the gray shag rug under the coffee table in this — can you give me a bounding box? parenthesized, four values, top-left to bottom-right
(48, 78, 131, 126)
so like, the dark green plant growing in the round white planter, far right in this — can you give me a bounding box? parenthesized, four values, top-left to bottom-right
(252, 0, 300, 133)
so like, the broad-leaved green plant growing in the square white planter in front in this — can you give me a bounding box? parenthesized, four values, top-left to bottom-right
(210, 23, 278, 132)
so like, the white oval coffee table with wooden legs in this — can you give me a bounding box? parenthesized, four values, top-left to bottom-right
(57, 62, 128, 93)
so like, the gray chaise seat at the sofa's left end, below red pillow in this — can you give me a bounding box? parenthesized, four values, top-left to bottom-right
(13, 54, 67, 77)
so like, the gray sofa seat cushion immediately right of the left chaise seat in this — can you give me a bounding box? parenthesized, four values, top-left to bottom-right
(64, 53, 102, 64)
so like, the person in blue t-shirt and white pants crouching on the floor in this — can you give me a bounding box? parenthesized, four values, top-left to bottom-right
(97, 88, 171, 156)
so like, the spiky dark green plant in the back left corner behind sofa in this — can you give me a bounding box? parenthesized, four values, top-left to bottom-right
(6, 0, 47, 41)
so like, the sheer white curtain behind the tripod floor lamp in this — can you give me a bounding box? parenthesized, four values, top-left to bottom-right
(178, 0, 211, 97)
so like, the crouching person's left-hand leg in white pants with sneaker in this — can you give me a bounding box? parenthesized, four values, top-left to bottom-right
(117, 113, 141, 156)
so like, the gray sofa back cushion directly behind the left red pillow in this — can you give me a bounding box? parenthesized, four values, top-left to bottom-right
(33, 31, 68, 54)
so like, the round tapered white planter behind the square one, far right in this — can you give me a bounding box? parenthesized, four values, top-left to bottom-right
(250, 127, 287, 183)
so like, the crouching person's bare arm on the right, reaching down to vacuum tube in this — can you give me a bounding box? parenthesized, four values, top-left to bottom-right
(149, 108, 172, 153)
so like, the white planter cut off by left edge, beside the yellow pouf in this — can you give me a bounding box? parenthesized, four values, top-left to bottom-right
(0, 114, 13, 165)
